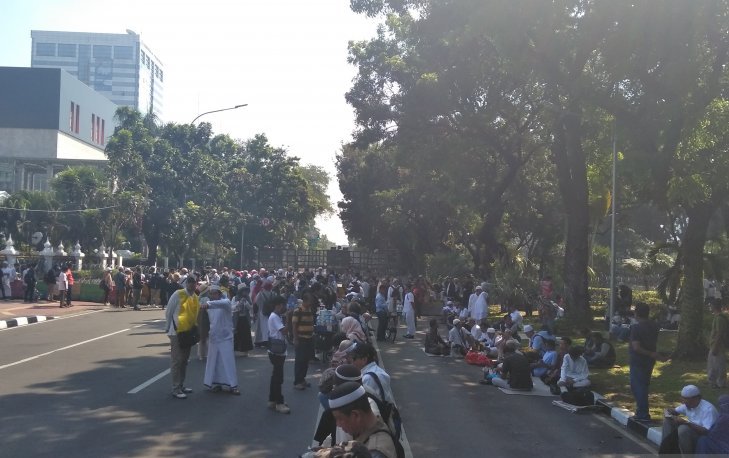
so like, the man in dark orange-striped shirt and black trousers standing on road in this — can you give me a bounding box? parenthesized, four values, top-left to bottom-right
(291, 292, 318, 390)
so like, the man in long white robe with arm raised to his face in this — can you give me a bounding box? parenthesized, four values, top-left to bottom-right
(200, 285, 240, 395)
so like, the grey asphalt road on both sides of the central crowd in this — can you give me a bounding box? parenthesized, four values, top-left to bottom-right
(0, 307, 655, 458)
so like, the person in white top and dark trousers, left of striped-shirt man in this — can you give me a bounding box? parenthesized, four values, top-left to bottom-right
(264, 296, 291, 413)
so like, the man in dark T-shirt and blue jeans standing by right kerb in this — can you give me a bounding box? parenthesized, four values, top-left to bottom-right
(630, 304, 660, 421)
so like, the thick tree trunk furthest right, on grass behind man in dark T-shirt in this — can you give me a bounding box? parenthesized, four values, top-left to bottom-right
(675, 205, 714, 360)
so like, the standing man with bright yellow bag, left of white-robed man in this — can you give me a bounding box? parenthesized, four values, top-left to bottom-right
(165, 272, 200, 399)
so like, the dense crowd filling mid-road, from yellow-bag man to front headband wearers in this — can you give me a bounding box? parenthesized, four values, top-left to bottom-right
(161, 268, 404, 458)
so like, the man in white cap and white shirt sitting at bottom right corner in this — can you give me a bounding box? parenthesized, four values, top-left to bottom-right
(659, 385, 719, 456)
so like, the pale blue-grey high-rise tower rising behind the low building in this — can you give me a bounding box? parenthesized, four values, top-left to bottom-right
(30, 30, 165, 120)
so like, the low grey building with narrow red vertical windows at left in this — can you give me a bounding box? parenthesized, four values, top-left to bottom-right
(0, 67, 117, 193)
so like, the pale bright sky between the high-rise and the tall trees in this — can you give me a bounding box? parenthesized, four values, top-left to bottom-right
(0, 0, 376, 244)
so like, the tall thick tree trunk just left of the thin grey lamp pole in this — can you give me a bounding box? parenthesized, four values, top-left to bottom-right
(552, 110, 592, 326)
